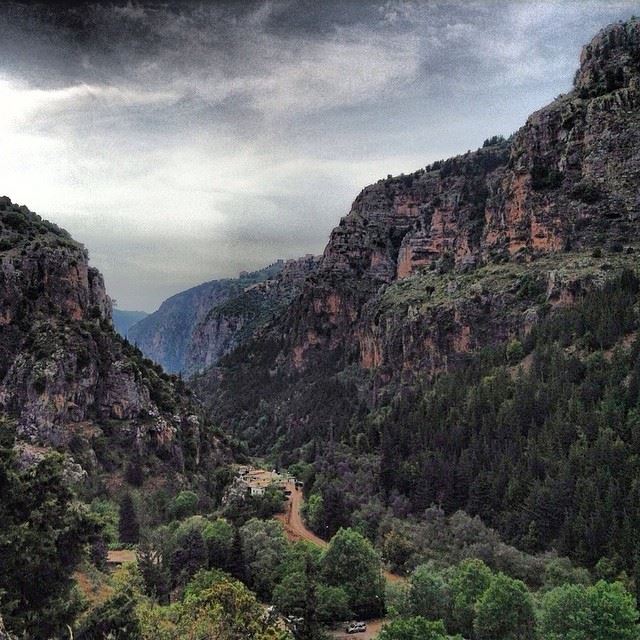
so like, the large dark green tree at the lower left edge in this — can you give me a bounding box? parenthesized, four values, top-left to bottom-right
(0, 440, 100, 638)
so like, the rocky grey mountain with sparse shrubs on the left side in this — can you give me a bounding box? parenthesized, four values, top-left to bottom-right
(0, 196, 224, 482)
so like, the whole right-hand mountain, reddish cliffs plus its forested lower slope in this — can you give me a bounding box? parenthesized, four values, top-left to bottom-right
(194, 19, 640, 570)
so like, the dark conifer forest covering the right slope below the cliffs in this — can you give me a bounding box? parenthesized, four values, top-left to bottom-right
(248, 271, 640, 575)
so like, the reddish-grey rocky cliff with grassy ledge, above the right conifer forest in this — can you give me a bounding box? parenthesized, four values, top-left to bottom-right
(199, 20, 640, 442)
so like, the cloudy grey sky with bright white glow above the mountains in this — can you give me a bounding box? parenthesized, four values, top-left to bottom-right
(0, 0, 640, 311)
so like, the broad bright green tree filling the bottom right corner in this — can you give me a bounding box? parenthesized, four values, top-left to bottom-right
(540, 580, 638, 640)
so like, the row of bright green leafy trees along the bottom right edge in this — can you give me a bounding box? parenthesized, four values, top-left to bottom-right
(379, 560, 638, 640)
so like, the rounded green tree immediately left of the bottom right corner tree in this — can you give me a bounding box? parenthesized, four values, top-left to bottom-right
(474, 573, 535, 640)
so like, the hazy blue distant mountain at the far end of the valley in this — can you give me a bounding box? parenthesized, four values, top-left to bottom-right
(128, 255, 318, 374)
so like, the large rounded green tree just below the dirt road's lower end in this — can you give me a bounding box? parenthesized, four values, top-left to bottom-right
(321, 529, 384, 618)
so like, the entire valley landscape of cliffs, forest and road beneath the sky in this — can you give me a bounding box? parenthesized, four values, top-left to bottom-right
(0, 4, 640, 640)
